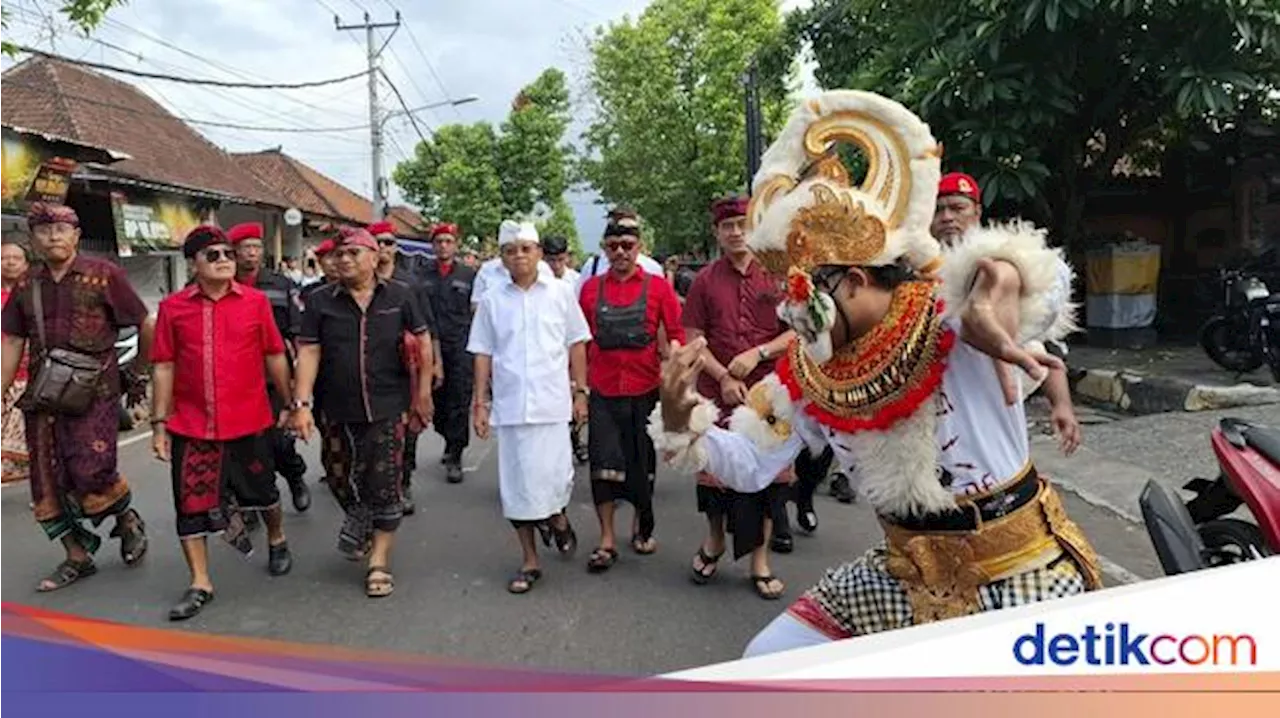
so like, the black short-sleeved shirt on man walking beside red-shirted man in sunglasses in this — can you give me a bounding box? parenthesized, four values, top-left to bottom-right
(298, 279, 426, 424)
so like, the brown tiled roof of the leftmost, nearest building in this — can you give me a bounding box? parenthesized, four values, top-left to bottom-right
(0, 58, 285, 206)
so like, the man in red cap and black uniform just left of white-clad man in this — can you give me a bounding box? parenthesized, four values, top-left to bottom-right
(422, 224, 476, 484)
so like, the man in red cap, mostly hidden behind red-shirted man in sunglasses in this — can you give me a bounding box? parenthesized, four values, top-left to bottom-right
(227, 221, 311, 512)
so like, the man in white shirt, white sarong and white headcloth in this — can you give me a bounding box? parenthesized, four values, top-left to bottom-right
(467, 221, 591, 594)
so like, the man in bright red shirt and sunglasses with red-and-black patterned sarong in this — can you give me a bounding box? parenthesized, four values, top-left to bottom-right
(151, 225, 293, 621)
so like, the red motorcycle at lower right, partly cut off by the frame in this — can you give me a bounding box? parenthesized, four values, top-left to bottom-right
(1139, 419, 1280, 576)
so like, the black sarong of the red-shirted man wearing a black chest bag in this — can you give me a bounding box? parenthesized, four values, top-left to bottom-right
(586, 390, 658, 540)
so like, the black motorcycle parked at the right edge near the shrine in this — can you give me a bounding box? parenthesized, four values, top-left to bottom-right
(1199, 258, 1280, 381)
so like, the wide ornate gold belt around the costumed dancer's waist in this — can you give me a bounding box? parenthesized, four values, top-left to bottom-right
(881, 479, 1102, 625)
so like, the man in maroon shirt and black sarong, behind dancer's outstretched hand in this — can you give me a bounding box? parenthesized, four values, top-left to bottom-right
(685, 197, 795, 599)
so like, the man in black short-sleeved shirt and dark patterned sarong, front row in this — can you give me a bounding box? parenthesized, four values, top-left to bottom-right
(293, 228, 434, 598)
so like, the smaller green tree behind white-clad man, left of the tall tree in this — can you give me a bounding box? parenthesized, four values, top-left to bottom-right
(392, 68, 572, 237)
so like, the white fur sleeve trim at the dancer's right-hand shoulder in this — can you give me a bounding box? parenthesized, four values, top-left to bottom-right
(938, 220, 1078, 343)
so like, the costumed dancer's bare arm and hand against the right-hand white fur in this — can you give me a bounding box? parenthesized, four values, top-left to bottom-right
(960, 259, 1066, 404)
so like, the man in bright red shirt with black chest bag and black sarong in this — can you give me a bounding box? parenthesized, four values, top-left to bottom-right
(579, 212, 685, 572)
